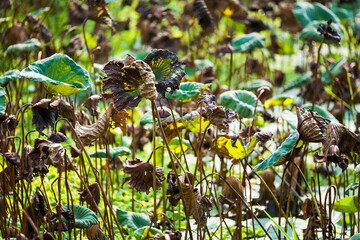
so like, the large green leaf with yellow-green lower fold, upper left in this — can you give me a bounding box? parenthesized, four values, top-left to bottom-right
(20, 54, 91, 96)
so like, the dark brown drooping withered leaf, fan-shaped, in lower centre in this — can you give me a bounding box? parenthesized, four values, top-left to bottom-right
(124, 159, 165, 194)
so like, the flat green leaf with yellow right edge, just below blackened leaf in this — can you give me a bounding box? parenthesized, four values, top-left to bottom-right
(165, 82, 211, 103)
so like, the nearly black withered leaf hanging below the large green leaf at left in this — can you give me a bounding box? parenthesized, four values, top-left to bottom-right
(32, 98, 58, 134)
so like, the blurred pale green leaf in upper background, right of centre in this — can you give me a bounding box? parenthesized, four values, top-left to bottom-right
(232, 32, 265, 53)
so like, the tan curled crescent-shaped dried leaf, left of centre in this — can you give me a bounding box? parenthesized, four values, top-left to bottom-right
(74, 105, 113, 146)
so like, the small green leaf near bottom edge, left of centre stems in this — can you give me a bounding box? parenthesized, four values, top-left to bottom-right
(116, 209, 151, 228)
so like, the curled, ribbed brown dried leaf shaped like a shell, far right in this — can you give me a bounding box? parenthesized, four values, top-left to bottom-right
(296, 108, 327, 142)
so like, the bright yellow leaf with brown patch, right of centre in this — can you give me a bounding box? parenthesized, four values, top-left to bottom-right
(214, 136, 246, 159)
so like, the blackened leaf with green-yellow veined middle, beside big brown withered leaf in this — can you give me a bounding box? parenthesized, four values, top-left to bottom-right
(144, 49, 185, 97)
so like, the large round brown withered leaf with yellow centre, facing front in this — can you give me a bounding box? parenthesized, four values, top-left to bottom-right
(101, 54, 157, 111)
